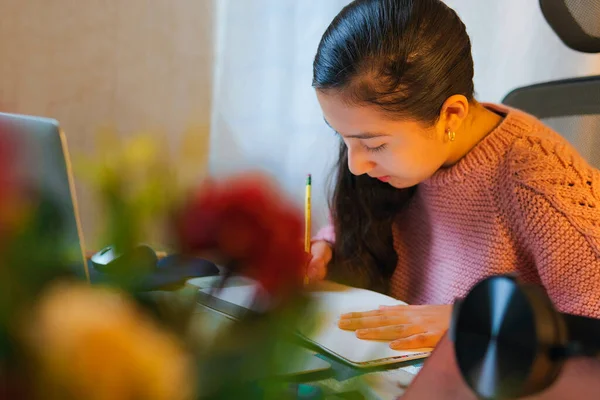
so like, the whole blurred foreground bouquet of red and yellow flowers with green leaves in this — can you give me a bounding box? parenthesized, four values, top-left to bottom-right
(0, 130, 318, 400)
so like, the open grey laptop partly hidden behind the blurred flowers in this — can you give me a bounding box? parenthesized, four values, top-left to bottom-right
(0, 113, 90, 282)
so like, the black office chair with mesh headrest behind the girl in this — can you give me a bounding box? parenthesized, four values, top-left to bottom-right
(502, 0, 600, 168)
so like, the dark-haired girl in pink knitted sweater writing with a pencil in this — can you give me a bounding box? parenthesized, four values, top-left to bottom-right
(309, 0, 600, 349)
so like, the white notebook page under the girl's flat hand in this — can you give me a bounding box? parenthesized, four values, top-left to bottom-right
(300, 283, 431, 366)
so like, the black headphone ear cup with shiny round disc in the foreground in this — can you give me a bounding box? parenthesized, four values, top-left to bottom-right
(450, 275, 600, 399)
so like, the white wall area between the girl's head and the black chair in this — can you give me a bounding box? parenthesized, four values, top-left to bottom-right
(446, 0, 600, 102)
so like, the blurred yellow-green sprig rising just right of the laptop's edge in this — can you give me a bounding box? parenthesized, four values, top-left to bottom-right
(74, 129, 181, 249)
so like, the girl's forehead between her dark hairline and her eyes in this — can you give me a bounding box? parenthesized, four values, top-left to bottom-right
(317, 90, 423, 136)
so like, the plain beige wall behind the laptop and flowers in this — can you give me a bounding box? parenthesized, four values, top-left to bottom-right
(0, 0, 213, 248)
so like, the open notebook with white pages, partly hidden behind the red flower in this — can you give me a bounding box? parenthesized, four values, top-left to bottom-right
(195, 279, 432, 367)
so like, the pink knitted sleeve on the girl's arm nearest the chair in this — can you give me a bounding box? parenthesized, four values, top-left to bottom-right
(503, 137, 600, 318)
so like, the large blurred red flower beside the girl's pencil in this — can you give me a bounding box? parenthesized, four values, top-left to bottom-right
(176, 175, 306, 294)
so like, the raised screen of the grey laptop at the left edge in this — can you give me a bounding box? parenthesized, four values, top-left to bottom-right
(0, 113, 89, 280)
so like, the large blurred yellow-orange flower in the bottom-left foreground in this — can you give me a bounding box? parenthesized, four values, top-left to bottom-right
(25, 283, 195, 400)
